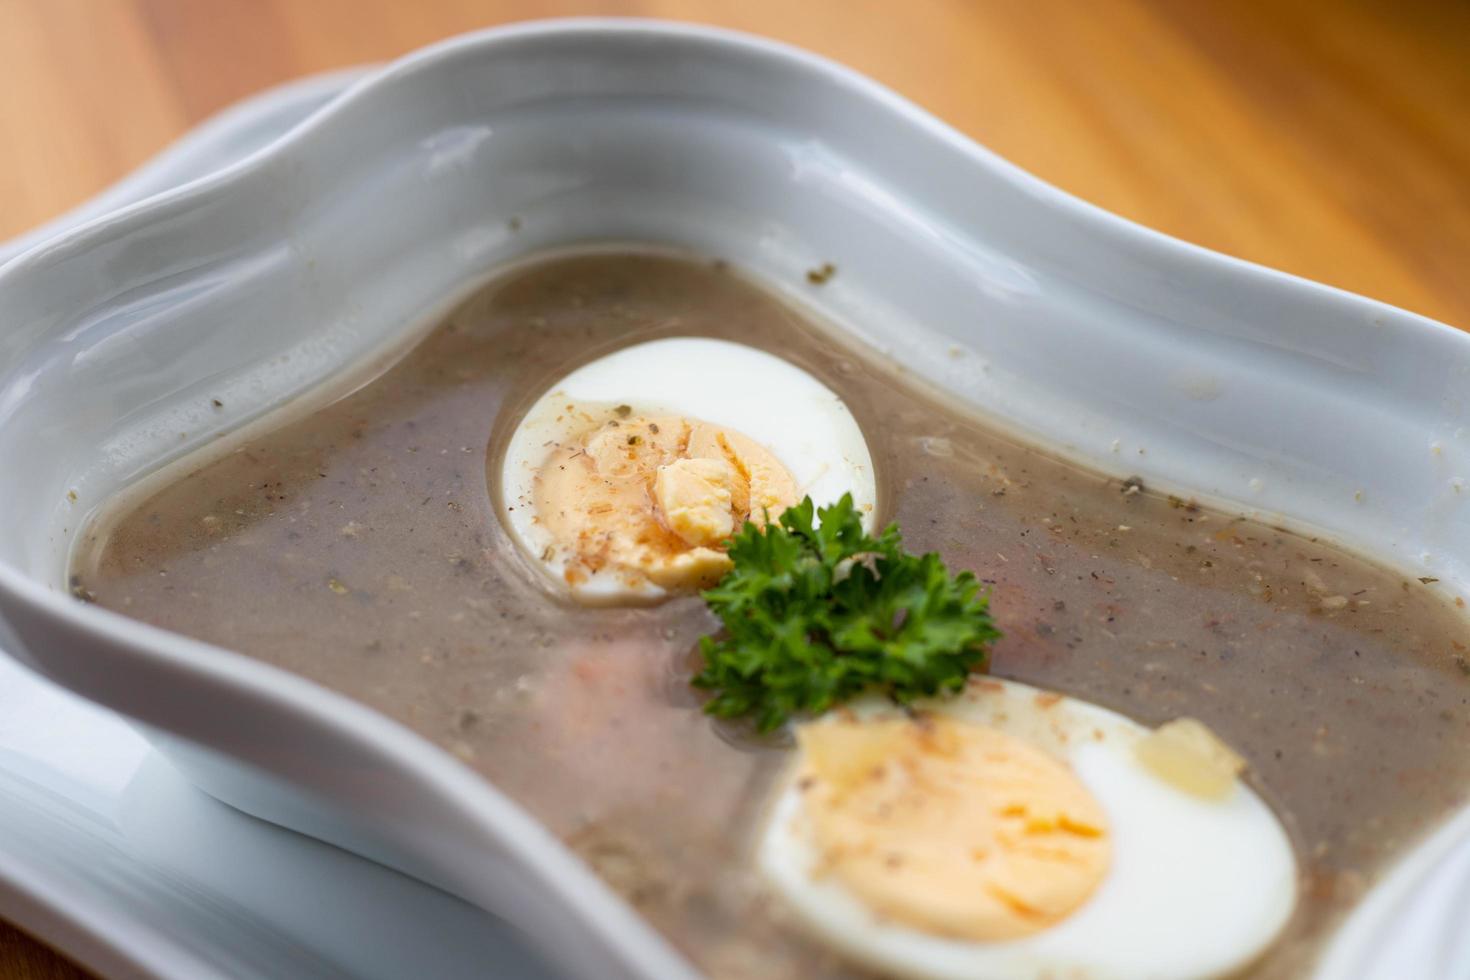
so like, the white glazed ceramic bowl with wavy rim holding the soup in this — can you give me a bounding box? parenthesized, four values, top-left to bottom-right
(0, 21, 1470, 980)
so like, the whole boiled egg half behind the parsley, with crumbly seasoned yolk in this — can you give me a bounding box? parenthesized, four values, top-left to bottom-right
(500, 336, 876, 602)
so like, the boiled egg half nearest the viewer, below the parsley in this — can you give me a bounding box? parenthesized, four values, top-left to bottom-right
(759, 679, 1297, 980)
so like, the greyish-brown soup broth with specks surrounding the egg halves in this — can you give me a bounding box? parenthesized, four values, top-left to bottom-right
(74, 253, 1470, 977)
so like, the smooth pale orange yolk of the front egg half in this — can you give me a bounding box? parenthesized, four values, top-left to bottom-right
(797, 716, 1113, 940)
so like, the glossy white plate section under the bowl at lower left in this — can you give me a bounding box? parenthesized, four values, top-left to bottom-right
(0, 660, 551, 980)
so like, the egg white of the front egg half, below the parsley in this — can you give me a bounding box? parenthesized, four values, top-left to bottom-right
(757, 679, 1297, 980)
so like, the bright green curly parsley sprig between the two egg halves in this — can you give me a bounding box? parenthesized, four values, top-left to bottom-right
(691, 495, 1001, 732)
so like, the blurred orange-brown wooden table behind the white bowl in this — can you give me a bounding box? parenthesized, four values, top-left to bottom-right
(0, 0, 1470, 979)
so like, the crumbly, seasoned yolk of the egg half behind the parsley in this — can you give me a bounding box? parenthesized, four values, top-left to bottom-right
(534, 406, 797, 591)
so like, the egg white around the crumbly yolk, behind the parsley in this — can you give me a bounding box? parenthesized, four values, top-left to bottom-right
(501, 336, 878, 602)
